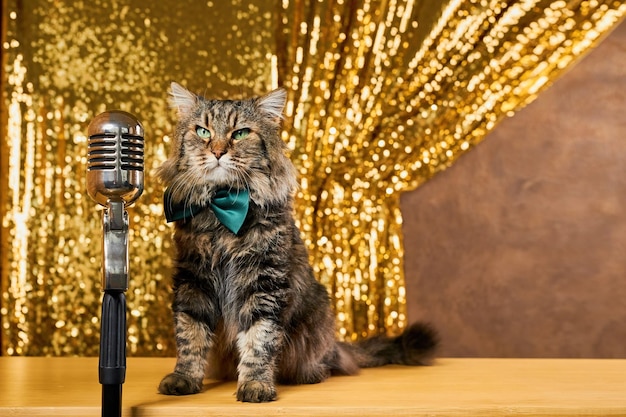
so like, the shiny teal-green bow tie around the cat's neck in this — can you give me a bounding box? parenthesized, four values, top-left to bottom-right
(163, 188, 250, 234)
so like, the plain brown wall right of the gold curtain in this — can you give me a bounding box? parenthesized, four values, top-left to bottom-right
(402, 22, 626, 358)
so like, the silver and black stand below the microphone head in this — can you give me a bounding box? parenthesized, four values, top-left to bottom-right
(98, 200, 128, 417)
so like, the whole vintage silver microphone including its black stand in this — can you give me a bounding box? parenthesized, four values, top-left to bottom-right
(87, 110, 144, 417)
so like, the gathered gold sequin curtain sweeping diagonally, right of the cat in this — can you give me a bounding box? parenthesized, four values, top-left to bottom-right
(277, 0, 626, 339)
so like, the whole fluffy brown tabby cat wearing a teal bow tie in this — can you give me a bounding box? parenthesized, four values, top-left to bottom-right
(156, 79, 438, 402)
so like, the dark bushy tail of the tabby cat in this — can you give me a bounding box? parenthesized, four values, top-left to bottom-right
(339, 323, 439, 372)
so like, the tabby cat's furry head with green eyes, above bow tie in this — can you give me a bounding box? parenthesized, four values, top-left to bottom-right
(157, 83, 296, 205)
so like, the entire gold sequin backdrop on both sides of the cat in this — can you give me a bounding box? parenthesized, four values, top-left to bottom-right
(0, 0, 626, 355)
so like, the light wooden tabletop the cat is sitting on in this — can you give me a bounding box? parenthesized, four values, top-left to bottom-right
(0, 357, 626, 417)
